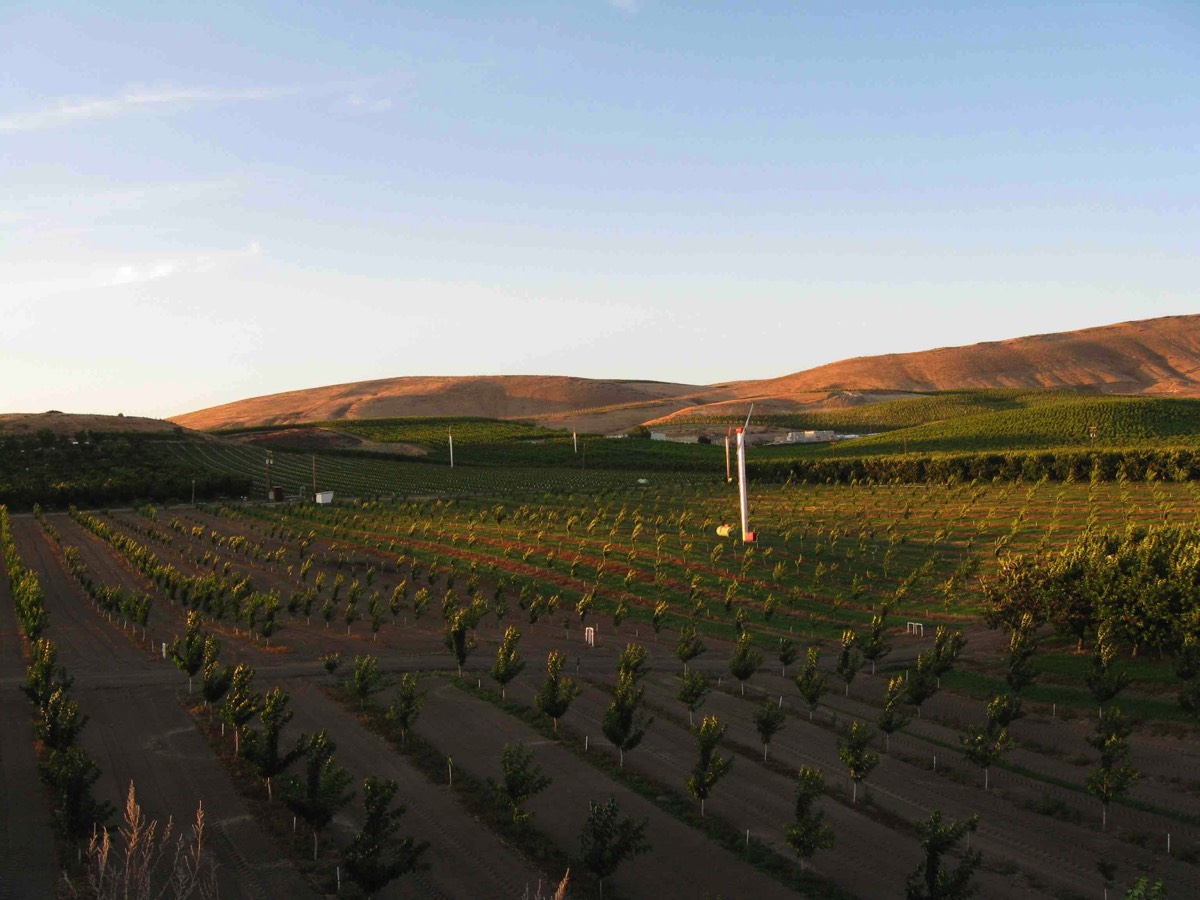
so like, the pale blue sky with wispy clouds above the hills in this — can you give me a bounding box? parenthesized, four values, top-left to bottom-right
(0, 0, 1200, 415)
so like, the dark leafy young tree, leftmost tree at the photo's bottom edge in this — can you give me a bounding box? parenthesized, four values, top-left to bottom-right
(342, 776, 430, 896)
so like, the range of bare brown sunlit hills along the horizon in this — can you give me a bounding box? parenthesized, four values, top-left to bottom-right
(172, 316, 1200, 432)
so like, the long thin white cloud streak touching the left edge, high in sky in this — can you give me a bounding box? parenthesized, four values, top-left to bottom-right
(0, 88, 298, 132)
